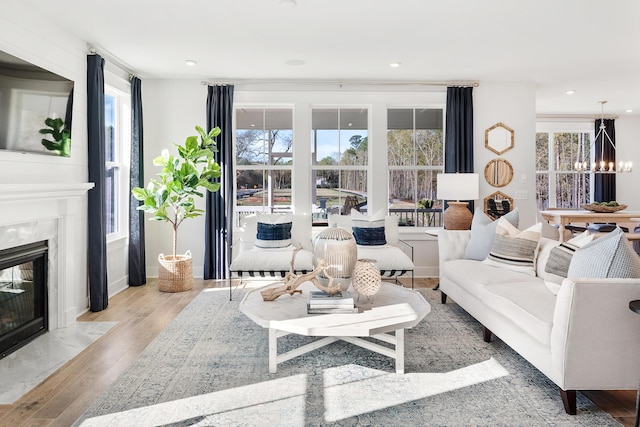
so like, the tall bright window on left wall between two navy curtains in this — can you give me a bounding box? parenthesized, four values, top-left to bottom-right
(104, 86, 131, 238)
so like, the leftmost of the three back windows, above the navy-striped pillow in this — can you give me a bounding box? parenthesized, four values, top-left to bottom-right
(235, 108, 293, 223)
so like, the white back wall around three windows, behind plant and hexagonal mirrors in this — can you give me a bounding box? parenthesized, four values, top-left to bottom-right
(143, 80, 535, 277)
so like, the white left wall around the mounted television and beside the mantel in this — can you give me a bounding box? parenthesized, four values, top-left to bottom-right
(0, 2, 93, 317)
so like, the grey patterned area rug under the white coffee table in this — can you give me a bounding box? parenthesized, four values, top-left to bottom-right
(74, 289, 619, 427)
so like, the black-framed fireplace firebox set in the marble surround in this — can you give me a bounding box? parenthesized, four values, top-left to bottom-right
(0, 241, 49, 359)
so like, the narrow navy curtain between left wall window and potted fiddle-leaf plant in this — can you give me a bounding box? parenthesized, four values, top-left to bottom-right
(129, 76, 147, 286)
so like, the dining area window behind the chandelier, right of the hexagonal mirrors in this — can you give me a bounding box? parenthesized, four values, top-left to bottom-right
(536, 125, 593, 210)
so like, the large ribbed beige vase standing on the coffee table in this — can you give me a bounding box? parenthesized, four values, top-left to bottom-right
(313, 224, 358, 291)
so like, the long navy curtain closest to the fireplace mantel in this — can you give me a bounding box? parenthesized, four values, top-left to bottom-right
(87, 55, 109, 311)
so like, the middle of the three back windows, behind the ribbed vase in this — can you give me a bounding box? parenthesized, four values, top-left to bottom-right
(311, 108, 369, 225)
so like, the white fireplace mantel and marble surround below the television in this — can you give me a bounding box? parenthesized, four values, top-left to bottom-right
(0, 182, 94, 330)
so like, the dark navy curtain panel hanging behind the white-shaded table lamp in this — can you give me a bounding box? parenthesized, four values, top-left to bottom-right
(444, 87, 474, 212)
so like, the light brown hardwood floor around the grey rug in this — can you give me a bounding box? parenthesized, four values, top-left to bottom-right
(0, 279, 636, 427)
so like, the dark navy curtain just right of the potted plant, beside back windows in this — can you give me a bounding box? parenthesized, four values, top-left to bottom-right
(204, 85, 234, 279)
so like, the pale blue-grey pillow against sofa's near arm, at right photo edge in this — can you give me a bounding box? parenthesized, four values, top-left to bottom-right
(567, 228, 640, 278)
